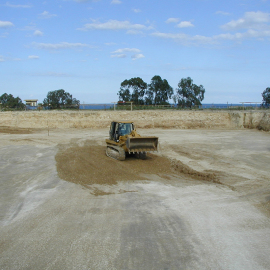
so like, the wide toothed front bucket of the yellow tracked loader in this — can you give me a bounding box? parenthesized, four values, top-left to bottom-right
(126, 137, 158, 152)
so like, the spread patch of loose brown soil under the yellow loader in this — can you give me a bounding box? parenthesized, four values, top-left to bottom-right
(55, 141, 218, 190)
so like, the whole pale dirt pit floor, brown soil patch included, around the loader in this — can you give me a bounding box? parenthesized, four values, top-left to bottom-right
(0, 127, 270, 270)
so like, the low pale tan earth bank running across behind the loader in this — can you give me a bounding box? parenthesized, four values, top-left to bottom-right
(0, 110, 270, 131)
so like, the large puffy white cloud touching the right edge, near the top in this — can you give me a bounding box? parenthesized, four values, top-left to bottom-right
(221, 11, 270, 31)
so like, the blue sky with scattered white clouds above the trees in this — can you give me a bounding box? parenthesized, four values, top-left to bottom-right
(0, 0, 270, 103)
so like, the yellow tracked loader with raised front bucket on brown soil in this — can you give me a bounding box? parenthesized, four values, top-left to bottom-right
(106, 121, 158, 160)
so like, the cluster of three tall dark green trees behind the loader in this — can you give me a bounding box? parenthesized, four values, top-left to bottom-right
(117, 75, 205, 108)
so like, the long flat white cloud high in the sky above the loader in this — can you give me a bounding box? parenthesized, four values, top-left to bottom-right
(77, 20, 147, 31)
